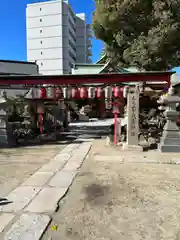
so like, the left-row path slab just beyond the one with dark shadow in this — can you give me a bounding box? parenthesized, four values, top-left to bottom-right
(21, 172, 54, 187)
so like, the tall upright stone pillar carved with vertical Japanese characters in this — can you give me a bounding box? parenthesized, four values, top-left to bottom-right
(123, 86, 142, 150)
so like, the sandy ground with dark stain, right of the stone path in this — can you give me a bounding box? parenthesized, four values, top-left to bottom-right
(43, 140, 180, 240)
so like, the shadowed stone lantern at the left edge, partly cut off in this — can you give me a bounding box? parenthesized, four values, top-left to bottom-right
(0, 96, 15, 148)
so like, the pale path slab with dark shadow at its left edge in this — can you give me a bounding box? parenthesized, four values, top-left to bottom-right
(0, 187, 40, 212)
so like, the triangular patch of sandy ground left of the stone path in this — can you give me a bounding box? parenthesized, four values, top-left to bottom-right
(0, 145, 65, 197)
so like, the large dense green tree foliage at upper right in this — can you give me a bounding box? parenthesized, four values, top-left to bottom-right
(93, 0, 180, 70)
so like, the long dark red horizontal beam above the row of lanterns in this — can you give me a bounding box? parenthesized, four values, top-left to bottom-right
(0, 72, 173, 86)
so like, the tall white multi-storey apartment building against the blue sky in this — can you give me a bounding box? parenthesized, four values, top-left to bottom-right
(26, 0, 92, 75)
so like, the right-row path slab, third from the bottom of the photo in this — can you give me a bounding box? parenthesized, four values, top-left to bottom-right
(48, 171, 76, 188)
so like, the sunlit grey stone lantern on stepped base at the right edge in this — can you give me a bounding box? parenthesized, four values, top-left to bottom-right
(158, 87, 180, 152)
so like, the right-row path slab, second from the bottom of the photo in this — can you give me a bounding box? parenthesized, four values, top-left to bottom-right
(25, 187, 67, 213)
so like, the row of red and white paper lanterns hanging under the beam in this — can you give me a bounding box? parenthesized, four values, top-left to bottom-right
(29, 86, 126, 99)
